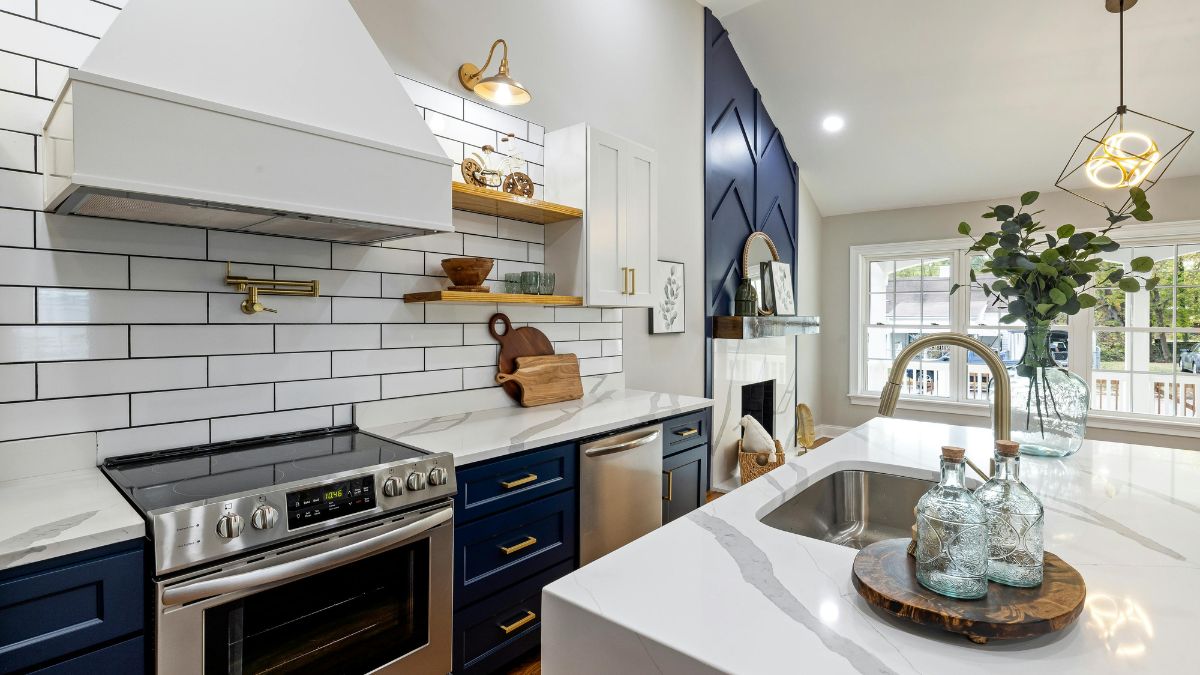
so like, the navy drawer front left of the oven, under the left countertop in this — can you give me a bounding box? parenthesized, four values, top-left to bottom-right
(0, 543, 145, 673)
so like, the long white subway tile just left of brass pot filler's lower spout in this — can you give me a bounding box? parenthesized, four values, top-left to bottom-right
(37, 288, 205, 323)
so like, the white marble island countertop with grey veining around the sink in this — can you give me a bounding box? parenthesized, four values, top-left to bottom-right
(541, 418, 1200, 675)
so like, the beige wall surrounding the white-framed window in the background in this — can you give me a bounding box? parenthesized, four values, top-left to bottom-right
(817, 177, 1200, 449)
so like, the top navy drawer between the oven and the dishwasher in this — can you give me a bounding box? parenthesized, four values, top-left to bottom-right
(454, 443, 578, 524)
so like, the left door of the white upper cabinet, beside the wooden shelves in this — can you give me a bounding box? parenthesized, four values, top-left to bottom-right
(586, 130, 628, 306)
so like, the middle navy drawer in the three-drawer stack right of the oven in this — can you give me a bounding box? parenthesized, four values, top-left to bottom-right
(454, 490, 577, 607)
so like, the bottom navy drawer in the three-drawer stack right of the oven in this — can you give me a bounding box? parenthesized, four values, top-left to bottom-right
(454, 561, 575, 675)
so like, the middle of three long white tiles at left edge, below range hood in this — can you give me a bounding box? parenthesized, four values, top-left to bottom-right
(0, 325, 130, 363)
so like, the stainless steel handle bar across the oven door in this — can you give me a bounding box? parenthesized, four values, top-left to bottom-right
(162, 507, 454, 605)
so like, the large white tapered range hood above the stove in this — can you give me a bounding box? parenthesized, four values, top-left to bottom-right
(43, 0, 454, 243)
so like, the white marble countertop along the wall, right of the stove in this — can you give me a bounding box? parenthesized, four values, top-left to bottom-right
(362, 389, 713, 466)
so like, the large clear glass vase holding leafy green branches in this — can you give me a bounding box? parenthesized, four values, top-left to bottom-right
(1008, 323, 1090, 458)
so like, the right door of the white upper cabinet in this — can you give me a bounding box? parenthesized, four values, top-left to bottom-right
(620, 142, 659, 307)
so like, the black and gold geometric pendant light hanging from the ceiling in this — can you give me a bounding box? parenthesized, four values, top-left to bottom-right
(1055, 0, 1192, 211)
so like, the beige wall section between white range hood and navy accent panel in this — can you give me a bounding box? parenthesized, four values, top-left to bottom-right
(353, 0, 704, 395)
